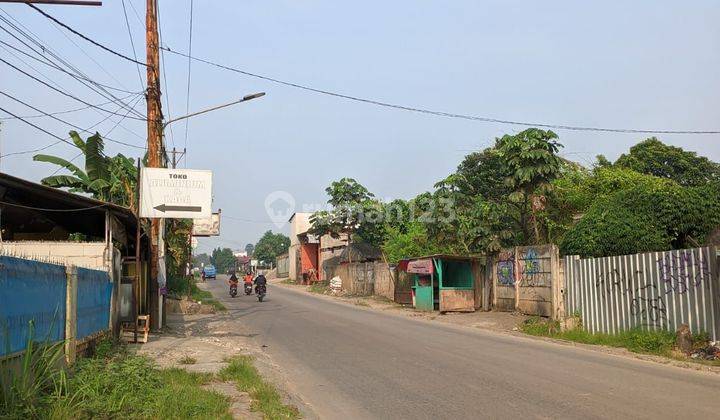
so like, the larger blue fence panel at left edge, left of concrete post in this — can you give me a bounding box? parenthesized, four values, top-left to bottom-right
(0, 256, 66, 355)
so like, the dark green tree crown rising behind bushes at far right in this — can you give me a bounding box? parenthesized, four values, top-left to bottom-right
(615, 137, 720, 186)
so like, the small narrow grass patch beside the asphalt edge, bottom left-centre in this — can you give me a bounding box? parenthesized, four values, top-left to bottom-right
(218, 356, 300, 419)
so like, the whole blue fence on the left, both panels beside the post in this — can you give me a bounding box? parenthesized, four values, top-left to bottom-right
(0, 255, 112, 356)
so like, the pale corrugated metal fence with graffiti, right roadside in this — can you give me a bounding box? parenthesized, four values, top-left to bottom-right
(564, 247, 720, 340)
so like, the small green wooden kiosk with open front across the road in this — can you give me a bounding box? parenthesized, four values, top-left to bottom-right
(406, 255, 483, 312)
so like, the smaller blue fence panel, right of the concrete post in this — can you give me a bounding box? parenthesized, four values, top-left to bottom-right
(77, 268, 112, 340)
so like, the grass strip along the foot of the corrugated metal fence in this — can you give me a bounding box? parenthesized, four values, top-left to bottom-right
(520, 317, 706, 358)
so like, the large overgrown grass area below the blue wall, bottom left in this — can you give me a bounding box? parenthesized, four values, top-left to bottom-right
(0, 343, 231, 419)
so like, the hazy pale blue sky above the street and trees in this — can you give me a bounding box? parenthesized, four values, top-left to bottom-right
(0, 0, 720, 252)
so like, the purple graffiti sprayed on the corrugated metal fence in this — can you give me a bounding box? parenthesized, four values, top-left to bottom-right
(657, 250, 710, 295)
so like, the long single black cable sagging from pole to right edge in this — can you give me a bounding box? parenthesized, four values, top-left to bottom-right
(160, 46, 720, 134)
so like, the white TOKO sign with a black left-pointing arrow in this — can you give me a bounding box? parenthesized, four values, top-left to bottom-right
(140, 168, 212, 219)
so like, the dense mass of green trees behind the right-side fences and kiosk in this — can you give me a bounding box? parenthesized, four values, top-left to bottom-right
(309, 128, 720, 263)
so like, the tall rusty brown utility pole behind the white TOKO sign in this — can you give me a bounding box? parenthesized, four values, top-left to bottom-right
(145, 0, 165, 329)
